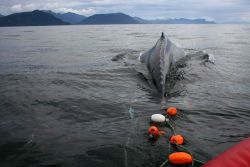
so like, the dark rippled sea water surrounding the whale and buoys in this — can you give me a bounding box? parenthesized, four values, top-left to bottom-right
(0, 25, 250, 167)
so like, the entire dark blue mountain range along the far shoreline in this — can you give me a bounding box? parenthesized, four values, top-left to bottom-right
(0, 10, 215, 26)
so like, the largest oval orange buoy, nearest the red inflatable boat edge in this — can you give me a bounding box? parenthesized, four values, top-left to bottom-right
(168, 152, 193, 165)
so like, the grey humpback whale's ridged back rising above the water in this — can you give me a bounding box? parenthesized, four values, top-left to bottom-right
(139, 32, 185, 96)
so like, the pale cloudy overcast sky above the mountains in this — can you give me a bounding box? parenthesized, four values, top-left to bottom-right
(0, 0, 250, 23)
